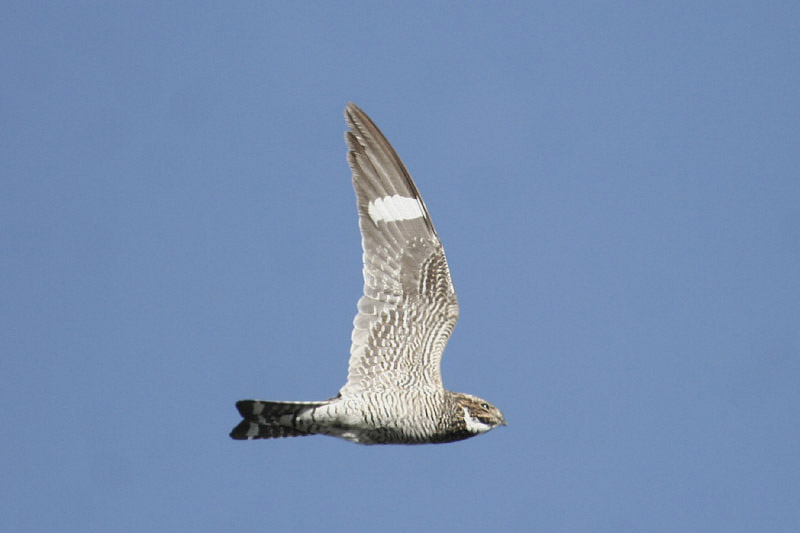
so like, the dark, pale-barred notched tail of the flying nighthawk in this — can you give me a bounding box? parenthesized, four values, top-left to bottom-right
(231, 400, 327, 440)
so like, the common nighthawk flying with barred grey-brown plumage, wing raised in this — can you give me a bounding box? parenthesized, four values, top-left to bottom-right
(231, 103, 506, 444)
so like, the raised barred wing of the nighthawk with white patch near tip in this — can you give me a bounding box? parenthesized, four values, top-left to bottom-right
(340, 103, 458, 396)
